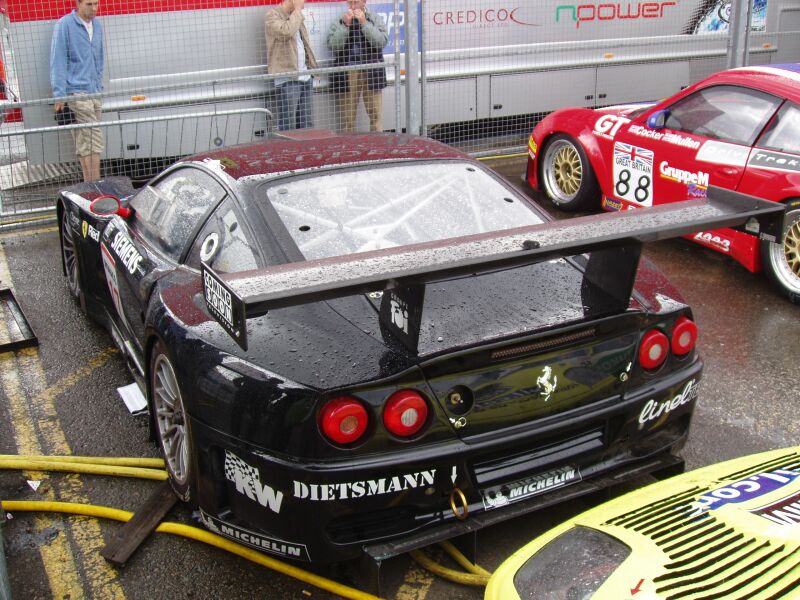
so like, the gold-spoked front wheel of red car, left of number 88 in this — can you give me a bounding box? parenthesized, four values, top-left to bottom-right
(539, 133, 600, 211)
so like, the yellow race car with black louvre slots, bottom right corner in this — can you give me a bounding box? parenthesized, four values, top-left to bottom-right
(485, 446, 800, 600)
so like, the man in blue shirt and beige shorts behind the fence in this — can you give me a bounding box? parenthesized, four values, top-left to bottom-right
(50, 0, 104, 181)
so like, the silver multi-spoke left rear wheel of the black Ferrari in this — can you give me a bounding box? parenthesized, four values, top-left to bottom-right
(150, 341, 196, 502)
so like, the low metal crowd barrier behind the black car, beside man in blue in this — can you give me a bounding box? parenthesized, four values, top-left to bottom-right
(0, 108, 272, 227)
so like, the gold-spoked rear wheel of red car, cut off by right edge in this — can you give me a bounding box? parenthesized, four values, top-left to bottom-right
(761, 198, 800, 304)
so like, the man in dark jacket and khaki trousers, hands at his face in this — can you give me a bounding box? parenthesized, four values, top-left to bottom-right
(328, 0, 389, 131)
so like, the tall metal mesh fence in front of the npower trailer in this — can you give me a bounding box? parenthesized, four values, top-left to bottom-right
(0, 0, 800, 226)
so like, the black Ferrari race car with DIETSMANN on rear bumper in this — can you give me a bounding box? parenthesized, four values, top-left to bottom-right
(58, 132, 782, 562)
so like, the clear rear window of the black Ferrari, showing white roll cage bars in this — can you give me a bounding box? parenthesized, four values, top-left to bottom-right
(262, 162, 542, 260)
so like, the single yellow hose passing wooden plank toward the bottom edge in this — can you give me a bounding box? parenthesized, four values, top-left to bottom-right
(2, 500, 380, 600)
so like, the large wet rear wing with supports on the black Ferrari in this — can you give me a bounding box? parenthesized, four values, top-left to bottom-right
(202, 186, 784, 352)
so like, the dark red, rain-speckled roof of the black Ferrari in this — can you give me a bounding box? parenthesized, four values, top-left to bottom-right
(183, 130, 473, 180)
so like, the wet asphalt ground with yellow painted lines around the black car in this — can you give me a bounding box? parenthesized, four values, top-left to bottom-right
(0, 159, 800, 600)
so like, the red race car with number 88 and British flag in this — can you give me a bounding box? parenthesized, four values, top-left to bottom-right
(526, 63, 800, 304)
